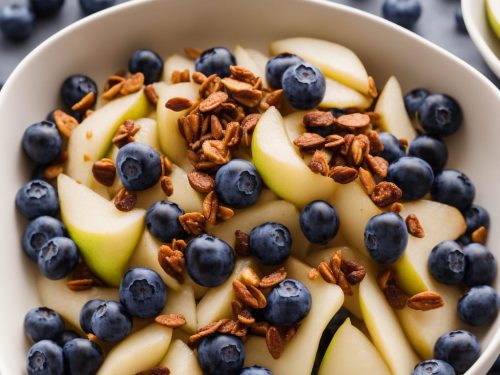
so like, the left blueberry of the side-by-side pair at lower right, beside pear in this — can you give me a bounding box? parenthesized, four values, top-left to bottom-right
(427, 241, 465, 284)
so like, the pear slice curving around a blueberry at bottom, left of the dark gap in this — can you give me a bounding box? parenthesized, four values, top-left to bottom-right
(245, 257, 344, 375)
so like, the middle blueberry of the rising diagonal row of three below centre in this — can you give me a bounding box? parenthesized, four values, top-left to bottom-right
(248, 222, 292, 266)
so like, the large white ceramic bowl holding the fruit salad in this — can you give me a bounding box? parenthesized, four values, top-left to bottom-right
(0, 0, 500, 375)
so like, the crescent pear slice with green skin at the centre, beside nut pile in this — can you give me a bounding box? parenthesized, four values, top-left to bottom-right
(252, 107, 337, 207)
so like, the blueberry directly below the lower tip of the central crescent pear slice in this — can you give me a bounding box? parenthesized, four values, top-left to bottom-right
(300, 201, 339, 244)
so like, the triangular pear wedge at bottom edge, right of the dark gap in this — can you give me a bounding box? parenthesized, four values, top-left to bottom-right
(318, 318, 390, 375)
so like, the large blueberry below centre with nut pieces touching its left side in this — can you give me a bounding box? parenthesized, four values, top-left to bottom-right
(184, 234, 234, 287)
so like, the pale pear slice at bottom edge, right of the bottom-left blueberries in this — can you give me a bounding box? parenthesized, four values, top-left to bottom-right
(97, 323, 172, 375)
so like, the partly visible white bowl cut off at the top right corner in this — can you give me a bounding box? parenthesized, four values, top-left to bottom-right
(462, 0, 500, 78)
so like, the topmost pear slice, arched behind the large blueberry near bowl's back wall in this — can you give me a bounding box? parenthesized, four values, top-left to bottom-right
(269, 38, 369, 95)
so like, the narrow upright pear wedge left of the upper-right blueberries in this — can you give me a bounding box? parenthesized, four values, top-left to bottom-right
(375, 76, 417, 142)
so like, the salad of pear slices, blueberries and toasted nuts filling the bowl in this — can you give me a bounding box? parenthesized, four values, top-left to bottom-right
(16, 37, 499, 375)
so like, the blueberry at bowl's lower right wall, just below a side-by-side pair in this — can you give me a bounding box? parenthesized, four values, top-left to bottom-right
(457, 285, 500, 326)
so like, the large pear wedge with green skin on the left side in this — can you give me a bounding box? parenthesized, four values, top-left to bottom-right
(57, 174, 146, 286)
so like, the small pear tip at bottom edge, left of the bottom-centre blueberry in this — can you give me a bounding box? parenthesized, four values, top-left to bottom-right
(158, 339, 203, 375)
